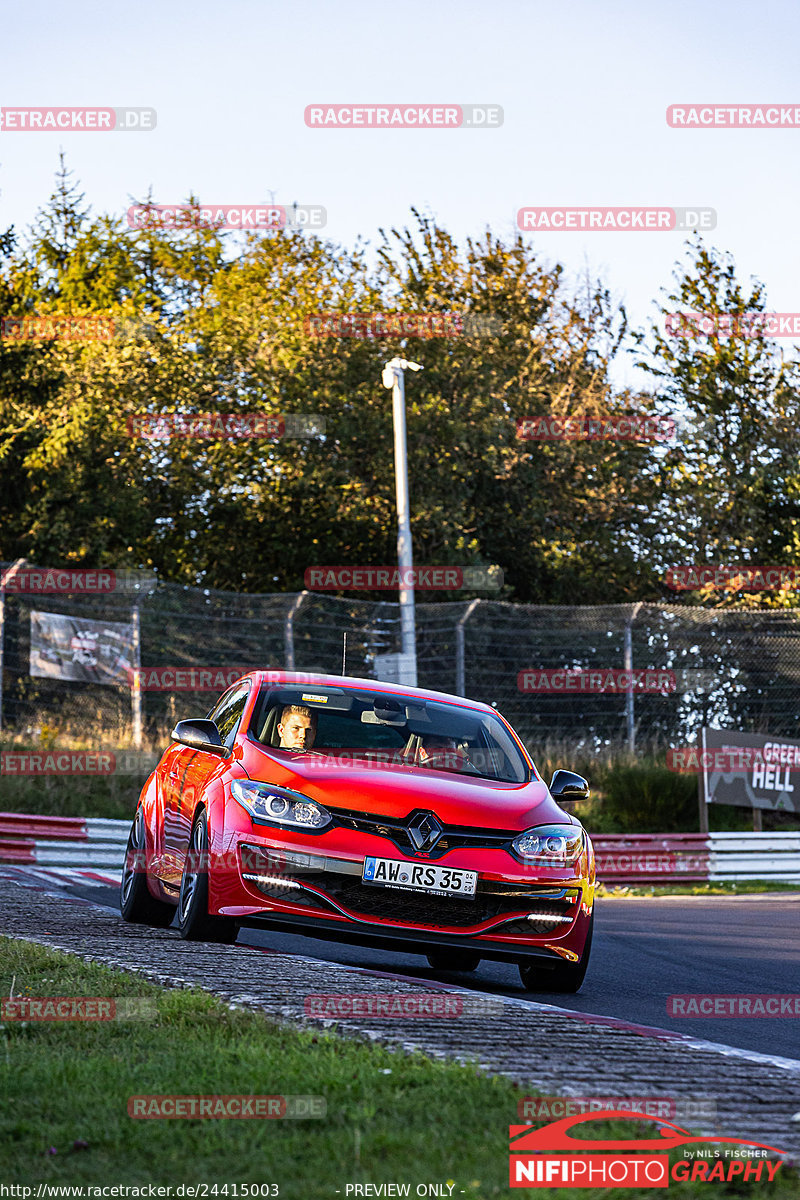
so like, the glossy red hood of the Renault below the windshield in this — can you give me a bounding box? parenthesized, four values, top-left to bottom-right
(242, 743, 578, 830)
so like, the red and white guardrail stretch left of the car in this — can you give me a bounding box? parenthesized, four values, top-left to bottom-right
(0, 812, 131, 866)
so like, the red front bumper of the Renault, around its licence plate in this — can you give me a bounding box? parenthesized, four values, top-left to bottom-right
(212, 830, 594, 962)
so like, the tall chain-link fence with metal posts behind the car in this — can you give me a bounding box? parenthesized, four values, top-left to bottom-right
(0, 564, 800, 752)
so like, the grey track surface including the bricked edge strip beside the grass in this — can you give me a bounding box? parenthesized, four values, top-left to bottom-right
(0, 868, 800, 1162)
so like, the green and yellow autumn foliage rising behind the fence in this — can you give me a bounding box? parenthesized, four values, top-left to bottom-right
(0, 160, 800, 604)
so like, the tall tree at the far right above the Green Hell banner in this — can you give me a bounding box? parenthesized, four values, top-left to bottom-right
(639, 239, 800, 604)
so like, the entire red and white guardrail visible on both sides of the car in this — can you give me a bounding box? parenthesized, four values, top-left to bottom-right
(0, 812, 800, 883)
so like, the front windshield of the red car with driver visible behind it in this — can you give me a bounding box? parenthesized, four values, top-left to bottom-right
(248, 686, 530, 784)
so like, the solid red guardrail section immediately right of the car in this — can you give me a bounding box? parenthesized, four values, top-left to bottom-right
(591, 833, 709, 883)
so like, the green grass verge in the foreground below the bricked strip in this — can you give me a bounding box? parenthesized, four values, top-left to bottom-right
(0, 938, 798, 1200)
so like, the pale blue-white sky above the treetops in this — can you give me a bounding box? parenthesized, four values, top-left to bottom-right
(0, 0, 800, 383)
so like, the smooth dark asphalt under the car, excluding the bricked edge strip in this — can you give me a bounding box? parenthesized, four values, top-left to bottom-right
(9, 886, 800, 1060)
